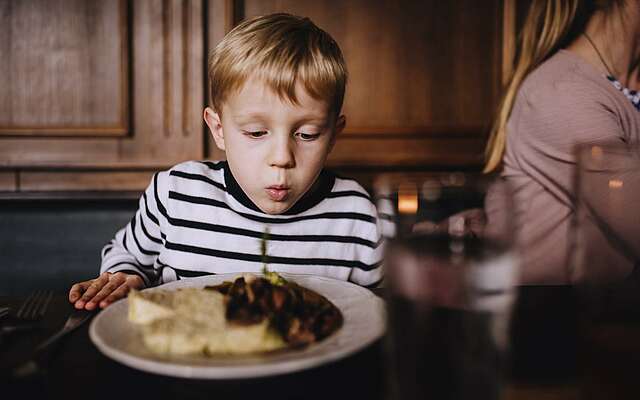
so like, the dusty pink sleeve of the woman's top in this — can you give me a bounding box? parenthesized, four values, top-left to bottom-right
(503, 78, 638, 279)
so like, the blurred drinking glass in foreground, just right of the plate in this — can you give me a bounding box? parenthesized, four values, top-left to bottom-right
(374, 173, 518, 400)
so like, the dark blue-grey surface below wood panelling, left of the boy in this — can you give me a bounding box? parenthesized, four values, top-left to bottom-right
(0, 198, 137, 296)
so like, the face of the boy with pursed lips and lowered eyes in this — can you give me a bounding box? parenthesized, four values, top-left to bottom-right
(204, 79, 345, 214)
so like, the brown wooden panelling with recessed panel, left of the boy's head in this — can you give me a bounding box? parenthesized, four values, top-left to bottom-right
(0, 0, 204, 190)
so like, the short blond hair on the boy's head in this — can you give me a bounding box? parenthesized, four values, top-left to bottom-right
(209, 13, 347, 115)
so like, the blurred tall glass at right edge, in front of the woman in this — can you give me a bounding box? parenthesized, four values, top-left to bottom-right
(571, 142, 640, 399)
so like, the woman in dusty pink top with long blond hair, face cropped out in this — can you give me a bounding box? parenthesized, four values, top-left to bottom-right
(485, 0, 640, 284)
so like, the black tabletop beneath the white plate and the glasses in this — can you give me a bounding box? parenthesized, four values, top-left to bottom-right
(0, 288, 640, 400)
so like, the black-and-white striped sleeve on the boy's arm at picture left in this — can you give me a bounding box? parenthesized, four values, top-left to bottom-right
(100, 173, 167, 287)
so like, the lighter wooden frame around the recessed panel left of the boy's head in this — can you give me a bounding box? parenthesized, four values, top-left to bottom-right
(0, 0, 204, 168)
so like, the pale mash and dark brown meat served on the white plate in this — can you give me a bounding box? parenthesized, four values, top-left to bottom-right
(129, 272, 342, 355)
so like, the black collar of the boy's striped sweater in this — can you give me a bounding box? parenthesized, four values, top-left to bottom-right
(223, 161, 335, 215)
